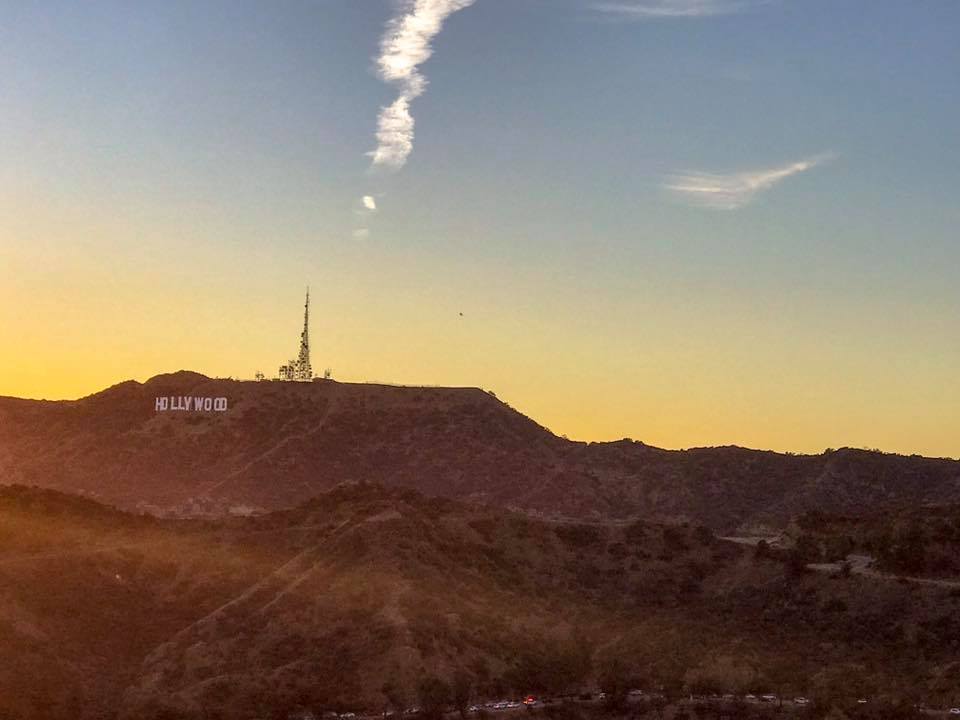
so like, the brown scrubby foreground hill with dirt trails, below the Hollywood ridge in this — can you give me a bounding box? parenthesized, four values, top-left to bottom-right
(0, 486, 960, 720)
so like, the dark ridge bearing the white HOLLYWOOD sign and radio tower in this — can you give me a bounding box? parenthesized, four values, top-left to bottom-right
(0, 372, 960, 531)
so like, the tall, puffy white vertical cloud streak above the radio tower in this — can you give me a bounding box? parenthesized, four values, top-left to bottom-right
(368, 0, 476, 170)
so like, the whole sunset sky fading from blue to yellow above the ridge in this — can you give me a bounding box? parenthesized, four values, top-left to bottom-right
(0, 0, 960, 457)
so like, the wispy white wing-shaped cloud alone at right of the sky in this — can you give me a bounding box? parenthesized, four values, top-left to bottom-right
(663, 153, 834, 210)
